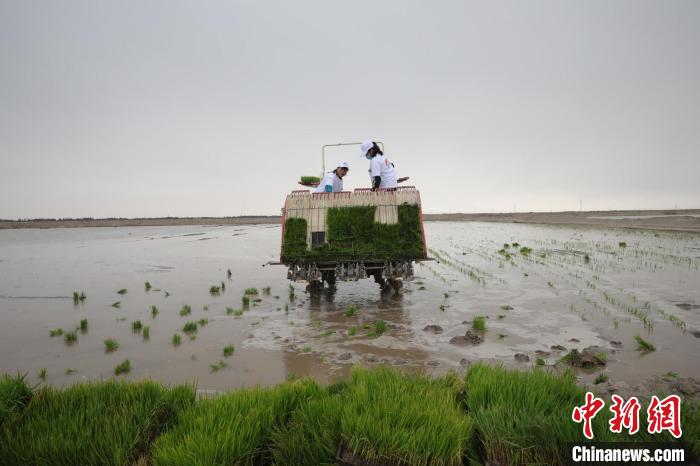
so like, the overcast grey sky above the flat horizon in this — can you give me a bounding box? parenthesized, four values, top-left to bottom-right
(0, 0, 700, 218)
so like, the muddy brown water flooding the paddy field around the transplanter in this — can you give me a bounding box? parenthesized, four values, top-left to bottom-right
(0, 222, 700, 390)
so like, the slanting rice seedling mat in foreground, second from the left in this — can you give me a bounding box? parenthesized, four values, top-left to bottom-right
(150, 380, 321, 466)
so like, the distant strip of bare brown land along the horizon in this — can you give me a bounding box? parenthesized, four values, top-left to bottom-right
(0, 209, 700, 233)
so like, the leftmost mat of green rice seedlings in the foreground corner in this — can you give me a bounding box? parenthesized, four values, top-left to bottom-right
(0, 381, 195, 465)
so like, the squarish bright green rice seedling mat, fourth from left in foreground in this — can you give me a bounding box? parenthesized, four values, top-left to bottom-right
(340, 367, 473, 465)
